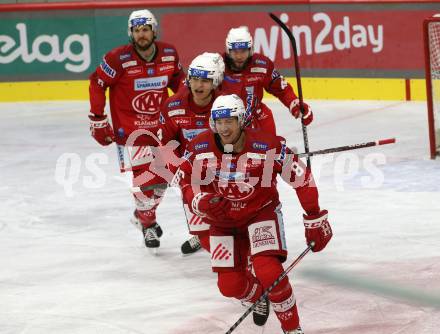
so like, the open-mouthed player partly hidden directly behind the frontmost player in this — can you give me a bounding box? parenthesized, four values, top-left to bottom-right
(162, 52, 225, 254)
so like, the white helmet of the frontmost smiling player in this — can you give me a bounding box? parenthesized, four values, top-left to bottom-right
(209, 94, 246, 133)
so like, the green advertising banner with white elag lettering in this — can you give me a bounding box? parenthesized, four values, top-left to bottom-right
(0, 15, 128, 81)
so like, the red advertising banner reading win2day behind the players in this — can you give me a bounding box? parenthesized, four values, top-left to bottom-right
(162, 10, 433, 71)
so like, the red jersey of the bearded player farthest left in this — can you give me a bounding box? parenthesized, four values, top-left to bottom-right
(90, 41, 185, 146)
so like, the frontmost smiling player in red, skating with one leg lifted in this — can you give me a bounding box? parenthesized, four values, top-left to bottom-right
(176, 94, 332, 334)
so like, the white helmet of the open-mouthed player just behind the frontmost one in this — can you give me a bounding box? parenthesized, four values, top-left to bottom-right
(187, 52, 225, 89)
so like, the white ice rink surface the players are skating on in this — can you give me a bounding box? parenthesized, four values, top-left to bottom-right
(0, 101, 440, 334)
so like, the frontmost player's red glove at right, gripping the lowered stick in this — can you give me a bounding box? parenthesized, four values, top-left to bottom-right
(303, 210, 333, 252)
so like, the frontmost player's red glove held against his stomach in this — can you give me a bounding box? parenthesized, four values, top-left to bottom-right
(191, 193, 231, 220)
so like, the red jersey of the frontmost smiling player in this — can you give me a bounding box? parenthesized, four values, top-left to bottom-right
(177, 129, 320, 227)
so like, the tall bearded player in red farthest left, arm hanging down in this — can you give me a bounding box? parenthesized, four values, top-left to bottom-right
(89, 10, 185, 248)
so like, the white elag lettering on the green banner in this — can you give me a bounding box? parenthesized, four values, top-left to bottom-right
(0, 23, 91, 73)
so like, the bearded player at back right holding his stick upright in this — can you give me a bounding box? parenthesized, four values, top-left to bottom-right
(222, 26, 313, 134)
